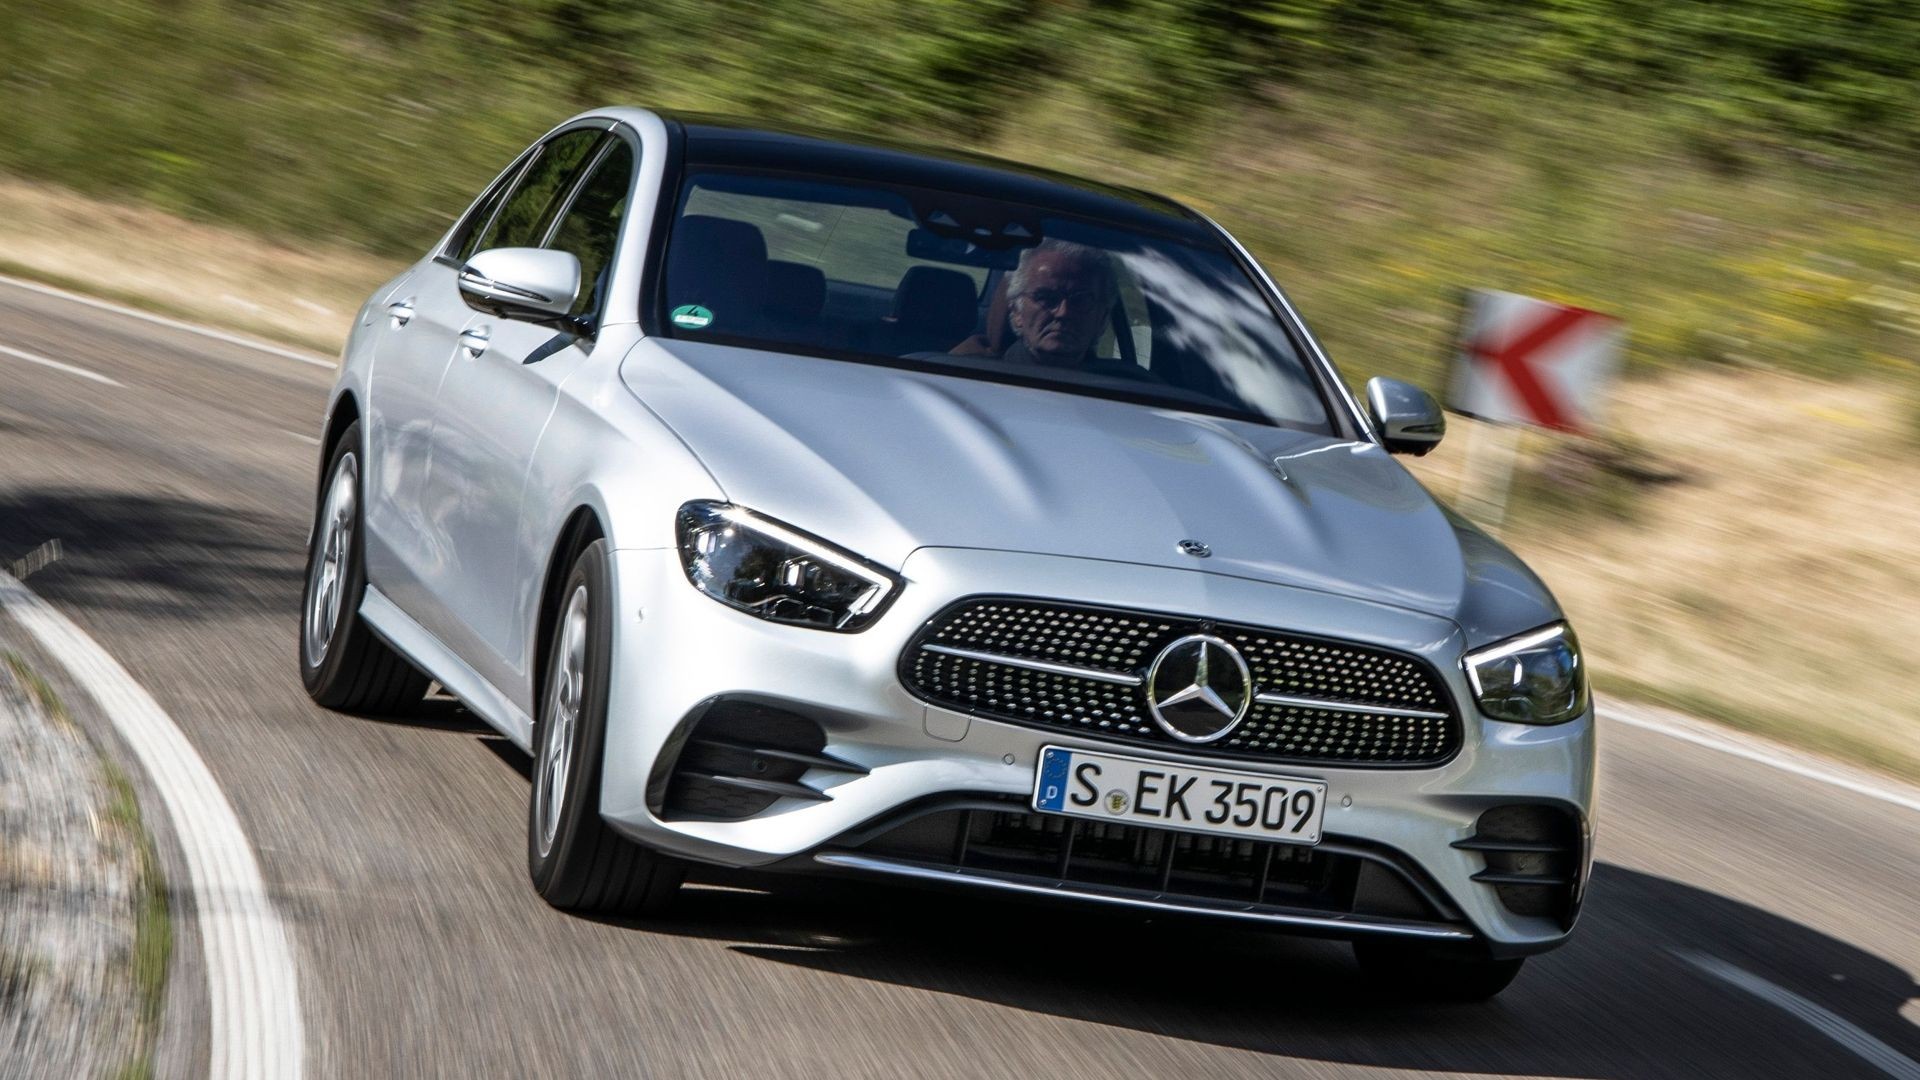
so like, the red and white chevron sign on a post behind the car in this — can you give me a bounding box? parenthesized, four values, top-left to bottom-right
(1448, 288, 1626, 432)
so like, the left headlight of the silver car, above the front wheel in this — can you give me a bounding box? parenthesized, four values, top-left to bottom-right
(678, 502, 900, 632)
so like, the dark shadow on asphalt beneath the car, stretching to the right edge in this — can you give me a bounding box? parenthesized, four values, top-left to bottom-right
(610, 865, 1920, 1078)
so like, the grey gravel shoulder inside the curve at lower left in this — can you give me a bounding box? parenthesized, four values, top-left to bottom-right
(0, 638, 173, 1078)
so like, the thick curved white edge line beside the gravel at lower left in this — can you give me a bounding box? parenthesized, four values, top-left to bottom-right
(0, 573, 305, 1080)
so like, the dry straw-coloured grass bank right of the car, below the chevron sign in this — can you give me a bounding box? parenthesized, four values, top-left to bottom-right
(1417, 369, 1920, 776)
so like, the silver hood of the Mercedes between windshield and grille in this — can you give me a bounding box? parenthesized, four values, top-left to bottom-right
(622, 338, 1557, 640)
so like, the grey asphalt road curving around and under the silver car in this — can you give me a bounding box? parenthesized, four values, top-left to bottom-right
(0, 284, 1920, 1080)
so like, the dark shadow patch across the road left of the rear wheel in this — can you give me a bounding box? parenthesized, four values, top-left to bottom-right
(0, 488, 303, 619)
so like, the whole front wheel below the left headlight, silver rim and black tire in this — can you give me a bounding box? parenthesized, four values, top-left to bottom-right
(526, 540, 684, 915)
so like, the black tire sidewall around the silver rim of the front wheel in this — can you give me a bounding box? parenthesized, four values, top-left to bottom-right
(526, 540, 612, 897)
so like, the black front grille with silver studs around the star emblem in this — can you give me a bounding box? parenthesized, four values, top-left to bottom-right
(900, 598, 1459, 767)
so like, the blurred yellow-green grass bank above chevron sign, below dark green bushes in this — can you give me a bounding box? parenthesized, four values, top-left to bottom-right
(989, 81, 1920, 390)
